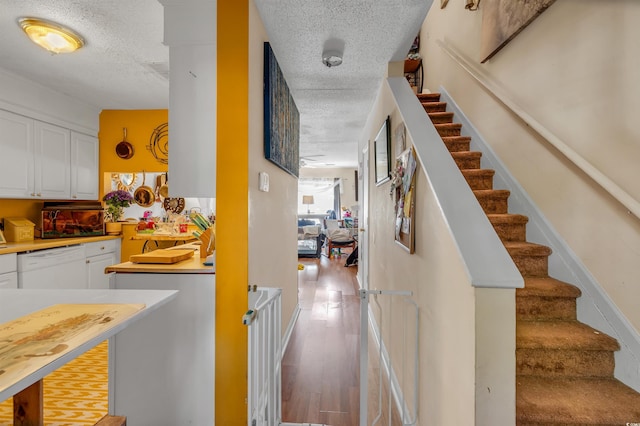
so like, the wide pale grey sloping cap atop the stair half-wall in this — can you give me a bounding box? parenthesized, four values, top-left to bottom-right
(387, 77, 524, 288)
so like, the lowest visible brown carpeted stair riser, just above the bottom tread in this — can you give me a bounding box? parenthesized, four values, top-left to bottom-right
(516, 350, 614, 377)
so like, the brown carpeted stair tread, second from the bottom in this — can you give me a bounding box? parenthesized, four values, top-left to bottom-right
(516, 321, 620, 351)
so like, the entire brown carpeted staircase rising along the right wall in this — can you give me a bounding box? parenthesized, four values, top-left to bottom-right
(418, 93, 640, 426)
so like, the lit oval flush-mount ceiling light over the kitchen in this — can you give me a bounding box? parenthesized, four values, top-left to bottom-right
(18, 18, 84, 53)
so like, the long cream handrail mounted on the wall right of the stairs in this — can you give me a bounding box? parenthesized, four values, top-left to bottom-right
(436, 40, 640, 218)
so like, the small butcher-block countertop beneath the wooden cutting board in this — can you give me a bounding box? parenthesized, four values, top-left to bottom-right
(105, 243, 216, 274)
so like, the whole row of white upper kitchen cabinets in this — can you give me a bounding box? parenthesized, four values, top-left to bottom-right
(0, 110, 98, 200)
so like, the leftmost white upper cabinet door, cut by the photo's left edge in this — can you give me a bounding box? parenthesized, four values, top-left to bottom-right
(0, 110, 35, 198)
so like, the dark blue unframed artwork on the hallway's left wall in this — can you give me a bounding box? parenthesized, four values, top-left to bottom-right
(264, 43, 300, 177)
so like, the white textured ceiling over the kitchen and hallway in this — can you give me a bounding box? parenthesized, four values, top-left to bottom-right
(0, 0, 432, 167)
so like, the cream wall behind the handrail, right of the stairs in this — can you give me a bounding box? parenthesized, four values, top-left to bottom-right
(421, 0, 640, 330)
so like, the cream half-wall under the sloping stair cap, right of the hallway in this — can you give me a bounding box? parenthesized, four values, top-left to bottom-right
(360, 79, 508, 425)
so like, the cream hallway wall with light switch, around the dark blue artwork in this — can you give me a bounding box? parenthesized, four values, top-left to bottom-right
(249, 1, 298, 330)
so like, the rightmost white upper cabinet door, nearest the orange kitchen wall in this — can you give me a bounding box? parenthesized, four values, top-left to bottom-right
(71, 132, 98, 200)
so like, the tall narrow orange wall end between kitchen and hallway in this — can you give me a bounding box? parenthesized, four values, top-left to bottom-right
(215, 1, 249, 425)
